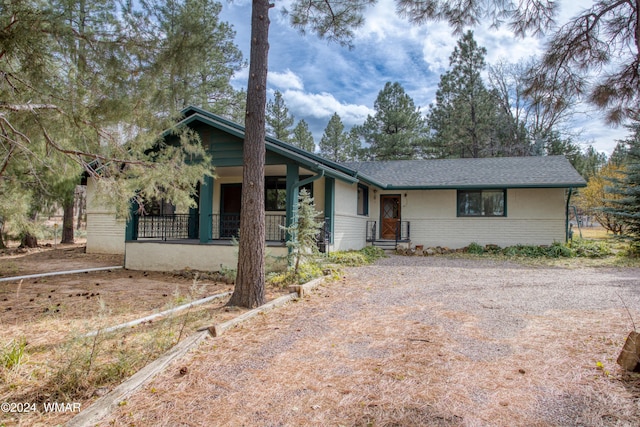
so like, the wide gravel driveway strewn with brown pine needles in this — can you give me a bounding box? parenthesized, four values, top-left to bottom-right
(104, 256, 640, 426)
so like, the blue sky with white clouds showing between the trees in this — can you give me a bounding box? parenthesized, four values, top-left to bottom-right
(220, 0, 627, 154)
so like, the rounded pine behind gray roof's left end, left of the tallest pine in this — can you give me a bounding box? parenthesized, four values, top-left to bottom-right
(358, 82, 426, 160)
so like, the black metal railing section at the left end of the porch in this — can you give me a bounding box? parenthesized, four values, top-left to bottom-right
(136, 214, 198, 240)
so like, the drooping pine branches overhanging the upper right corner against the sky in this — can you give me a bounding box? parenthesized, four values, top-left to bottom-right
(530, 0, 640, 124)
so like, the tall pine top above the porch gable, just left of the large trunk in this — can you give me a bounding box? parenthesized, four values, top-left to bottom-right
(141, 0, 244, 117)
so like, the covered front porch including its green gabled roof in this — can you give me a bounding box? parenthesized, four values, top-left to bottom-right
(117, 107, 357, 271)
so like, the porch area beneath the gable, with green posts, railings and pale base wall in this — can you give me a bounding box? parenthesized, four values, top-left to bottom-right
(125, 163, 333, 271)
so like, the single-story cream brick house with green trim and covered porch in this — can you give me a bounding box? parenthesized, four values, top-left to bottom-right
(87, 107, 586, 271)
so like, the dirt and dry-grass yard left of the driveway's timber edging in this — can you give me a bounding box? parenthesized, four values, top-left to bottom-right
(0, 244, 286, 426)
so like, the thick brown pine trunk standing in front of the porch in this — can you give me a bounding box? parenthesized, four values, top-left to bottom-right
(228, 0, 270, 308)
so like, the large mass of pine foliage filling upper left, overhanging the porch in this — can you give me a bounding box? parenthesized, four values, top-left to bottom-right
(0, 0, 242, 237)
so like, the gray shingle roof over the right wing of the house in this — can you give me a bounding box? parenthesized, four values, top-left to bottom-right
(344, 156, 586, 188)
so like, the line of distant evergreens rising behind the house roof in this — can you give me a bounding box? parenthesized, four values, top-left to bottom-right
(266, 31, 606, 178)
